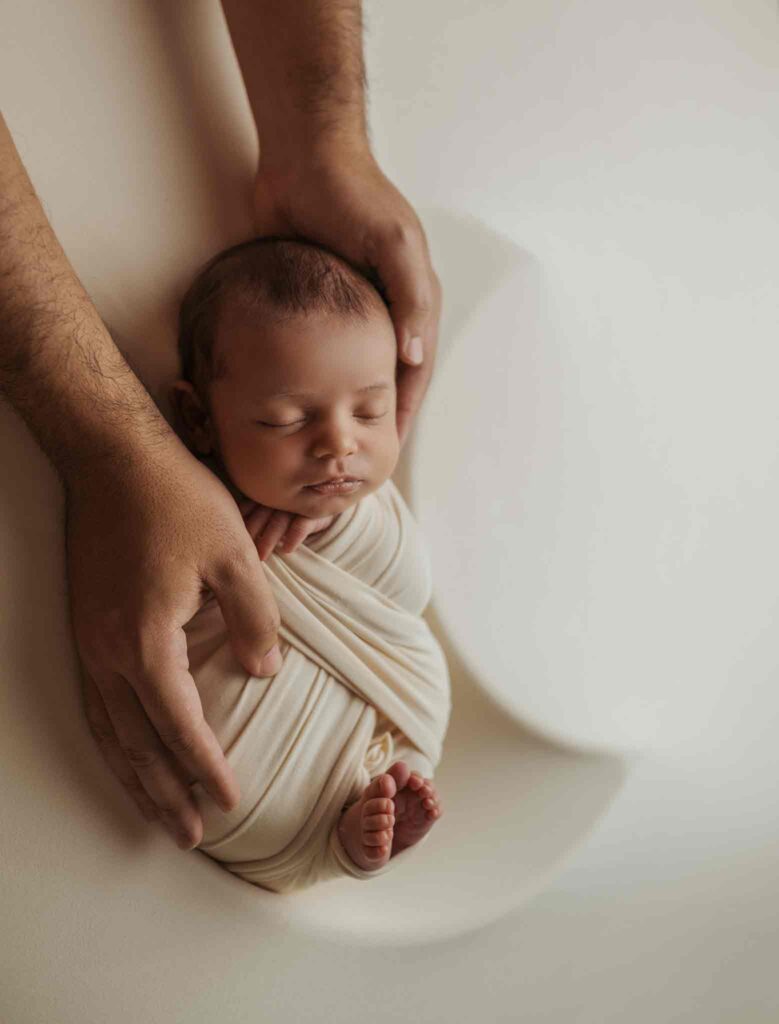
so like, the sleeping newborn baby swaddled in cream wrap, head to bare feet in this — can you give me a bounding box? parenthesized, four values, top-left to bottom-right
(170, 238, 450, 892)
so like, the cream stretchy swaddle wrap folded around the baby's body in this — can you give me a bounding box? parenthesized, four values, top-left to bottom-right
(184, 479, 451, 892)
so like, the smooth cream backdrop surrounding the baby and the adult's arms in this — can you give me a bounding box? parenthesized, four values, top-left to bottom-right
(0, 0, 779, 1024)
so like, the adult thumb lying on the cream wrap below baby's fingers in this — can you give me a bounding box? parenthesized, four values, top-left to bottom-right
(207, 548, 282, 676)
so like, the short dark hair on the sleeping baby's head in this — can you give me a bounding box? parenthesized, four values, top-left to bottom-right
(178, 236, 389, 408)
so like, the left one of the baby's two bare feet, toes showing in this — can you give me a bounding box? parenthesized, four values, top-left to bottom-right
(338, 761, 408, 871)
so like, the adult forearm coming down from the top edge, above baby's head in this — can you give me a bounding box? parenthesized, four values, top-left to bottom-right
(222, 0, 369, 165)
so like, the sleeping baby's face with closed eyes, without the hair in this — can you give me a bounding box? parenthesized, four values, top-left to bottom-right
(200, 303, 399, 518)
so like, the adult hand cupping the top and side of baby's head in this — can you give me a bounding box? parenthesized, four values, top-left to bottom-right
(254, 142, 442, 446)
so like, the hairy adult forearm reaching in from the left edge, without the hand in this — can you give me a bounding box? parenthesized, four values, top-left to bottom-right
(0, 115, 175, 479)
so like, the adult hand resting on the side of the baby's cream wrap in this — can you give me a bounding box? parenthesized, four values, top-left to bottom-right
(66, 442, 280, 849)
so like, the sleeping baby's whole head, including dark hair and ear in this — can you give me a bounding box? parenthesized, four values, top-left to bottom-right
(170, 237, 399, 517)
